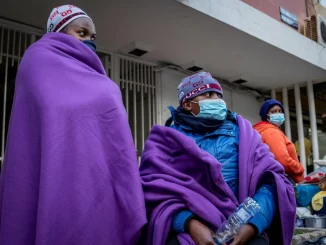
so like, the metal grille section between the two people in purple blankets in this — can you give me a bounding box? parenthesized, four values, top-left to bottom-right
(119, 58, 158, 159)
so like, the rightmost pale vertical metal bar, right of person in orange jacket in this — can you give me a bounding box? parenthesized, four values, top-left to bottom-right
(307, 81, 319, 169)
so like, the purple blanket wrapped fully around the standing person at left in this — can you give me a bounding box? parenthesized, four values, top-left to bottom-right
(0, 33, 146, 245)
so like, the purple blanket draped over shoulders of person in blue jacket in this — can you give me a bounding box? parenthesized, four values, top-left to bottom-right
(140, 116, 296, 245)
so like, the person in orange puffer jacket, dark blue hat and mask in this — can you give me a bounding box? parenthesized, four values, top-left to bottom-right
(254, 100, 304, 183)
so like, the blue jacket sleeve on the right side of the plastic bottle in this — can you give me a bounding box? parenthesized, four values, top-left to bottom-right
(249, 185, 276, 235)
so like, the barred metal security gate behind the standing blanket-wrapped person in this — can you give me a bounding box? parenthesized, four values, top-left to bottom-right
(0, 19, 160, 164)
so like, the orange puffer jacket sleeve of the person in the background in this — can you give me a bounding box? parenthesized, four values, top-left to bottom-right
(263, 129, 304, 183)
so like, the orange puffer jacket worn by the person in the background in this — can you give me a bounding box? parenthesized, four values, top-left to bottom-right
(254, 122, 304, 183)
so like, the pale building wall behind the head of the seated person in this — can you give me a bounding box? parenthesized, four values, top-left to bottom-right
(161, 70, 261, 124)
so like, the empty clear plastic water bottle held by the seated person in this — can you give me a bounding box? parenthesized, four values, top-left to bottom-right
(214, 197, 260, 245)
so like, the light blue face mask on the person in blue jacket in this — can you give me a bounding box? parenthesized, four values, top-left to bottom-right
(191, 99, 227, 120)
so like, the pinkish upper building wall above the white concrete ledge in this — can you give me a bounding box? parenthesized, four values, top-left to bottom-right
(242, 0, 311, 28)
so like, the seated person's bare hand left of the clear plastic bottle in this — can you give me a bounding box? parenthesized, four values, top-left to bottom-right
(189, 219, 222, 245)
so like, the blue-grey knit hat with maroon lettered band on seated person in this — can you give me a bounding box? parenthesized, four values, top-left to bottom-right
(178, 72, 223, 105)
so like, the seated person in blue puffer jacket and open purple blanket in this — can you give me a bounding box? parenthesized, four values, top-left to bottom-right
(140, 72, 296, 245)
